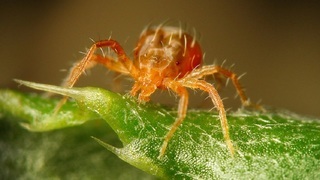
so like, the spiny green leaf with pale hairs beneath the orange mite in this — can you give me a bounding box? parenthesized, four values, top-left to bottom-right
(0, 81, 320, 179)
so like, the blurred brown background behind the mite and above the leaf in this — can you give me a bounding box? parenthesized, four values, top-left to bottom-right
(0, 0, 320, 117)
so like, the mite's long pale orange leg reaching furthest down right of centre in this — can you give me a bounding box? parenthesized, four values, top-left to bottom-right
(179, 78, 234, 156)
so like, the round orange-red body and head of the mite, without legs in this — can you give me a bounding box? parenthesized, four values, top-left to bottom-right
(131, 27, 202, 101)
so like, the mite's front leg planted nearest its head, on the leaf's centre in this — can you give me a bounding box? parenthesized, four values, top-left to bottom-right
(158, 81, 189, 158)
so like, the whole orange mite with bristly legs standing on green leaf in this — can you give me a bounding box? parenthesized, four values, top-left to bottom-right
(56, 25, 254, 157)
